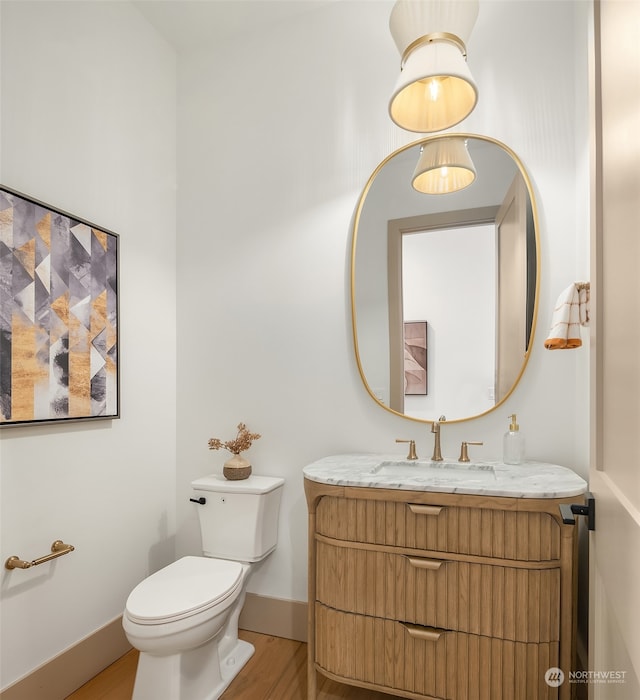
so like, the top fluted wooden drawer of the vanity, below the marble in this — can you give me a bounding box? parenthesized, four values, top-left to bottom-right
(316, 496, 560, 561)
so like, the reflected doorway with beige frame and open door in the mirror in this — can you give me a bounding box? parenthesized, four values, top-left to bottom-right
(388, 177, 536, 420)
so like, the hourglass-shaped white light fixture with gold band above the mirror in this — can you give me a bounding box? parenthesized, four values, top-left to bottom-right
(389, 0, 479, 133)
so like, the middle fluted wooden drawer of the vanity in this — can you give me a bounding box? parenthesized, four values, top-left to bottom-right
(316, 541, 560, 642)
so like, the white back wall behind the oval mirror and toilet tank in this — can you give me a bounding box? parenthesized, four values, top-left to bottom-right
(177, 0, 588, 600)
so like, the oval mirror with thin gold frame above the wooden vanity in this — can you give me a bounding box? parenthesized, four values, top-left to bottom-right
(351, 133, 540, 423)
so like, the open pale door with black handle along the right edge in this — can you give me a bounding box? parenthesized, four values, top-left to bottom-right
(589, 0, 640, 700)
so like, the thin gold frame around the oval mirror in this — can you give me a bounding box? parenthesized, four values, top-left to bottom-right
(350, 133, 541, 424)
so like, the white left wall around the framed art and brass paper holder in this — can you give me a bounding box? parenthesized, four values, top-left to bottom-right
(0, 0, 176, 687)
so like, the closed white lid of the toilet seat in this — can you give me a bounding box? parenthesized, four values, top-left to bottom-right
(126, 557, 242, 625)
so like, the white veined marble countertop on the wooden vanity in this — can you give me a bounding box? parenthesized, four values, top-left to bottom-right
(303, 454, 587, 498)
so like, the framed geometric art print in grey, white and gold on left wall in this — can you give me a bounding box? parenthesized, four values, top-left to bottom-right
(0, 187, 120, 427)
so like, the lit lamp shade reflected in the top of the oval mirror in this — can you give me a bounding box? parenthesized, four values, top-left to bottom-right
(411, 137, 476, 194)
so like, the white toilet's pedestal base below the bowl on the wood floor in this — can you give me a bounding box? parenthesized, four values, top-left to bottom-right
(132, 639, 255, 700)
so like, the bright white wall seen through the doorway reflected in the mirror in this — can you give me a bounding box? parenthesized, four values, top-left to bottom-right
(390, 216, 496, 420)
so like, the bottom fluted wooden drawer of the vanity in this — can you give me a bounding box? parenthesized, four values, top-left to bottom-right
(315, 603, 558, 700)
